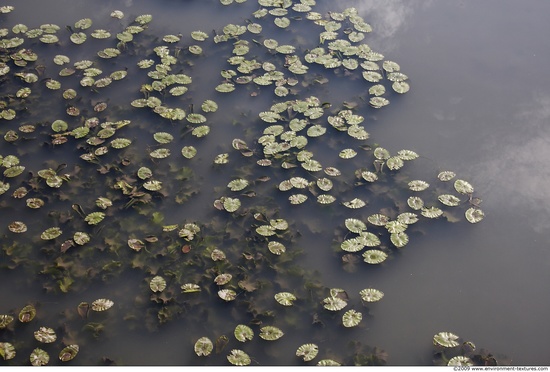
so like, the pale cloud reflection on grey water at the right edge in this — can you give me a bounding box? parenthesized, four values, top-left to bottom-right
(476, 92, 550, 232)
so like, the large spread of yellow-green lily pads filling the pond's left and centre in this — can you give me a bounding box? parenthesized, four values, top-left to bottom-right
(0, 0, 490, 365)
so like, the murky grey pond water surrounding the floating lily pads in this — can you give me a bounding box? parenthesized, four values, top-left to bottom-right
(0, 0, 550, 365)
